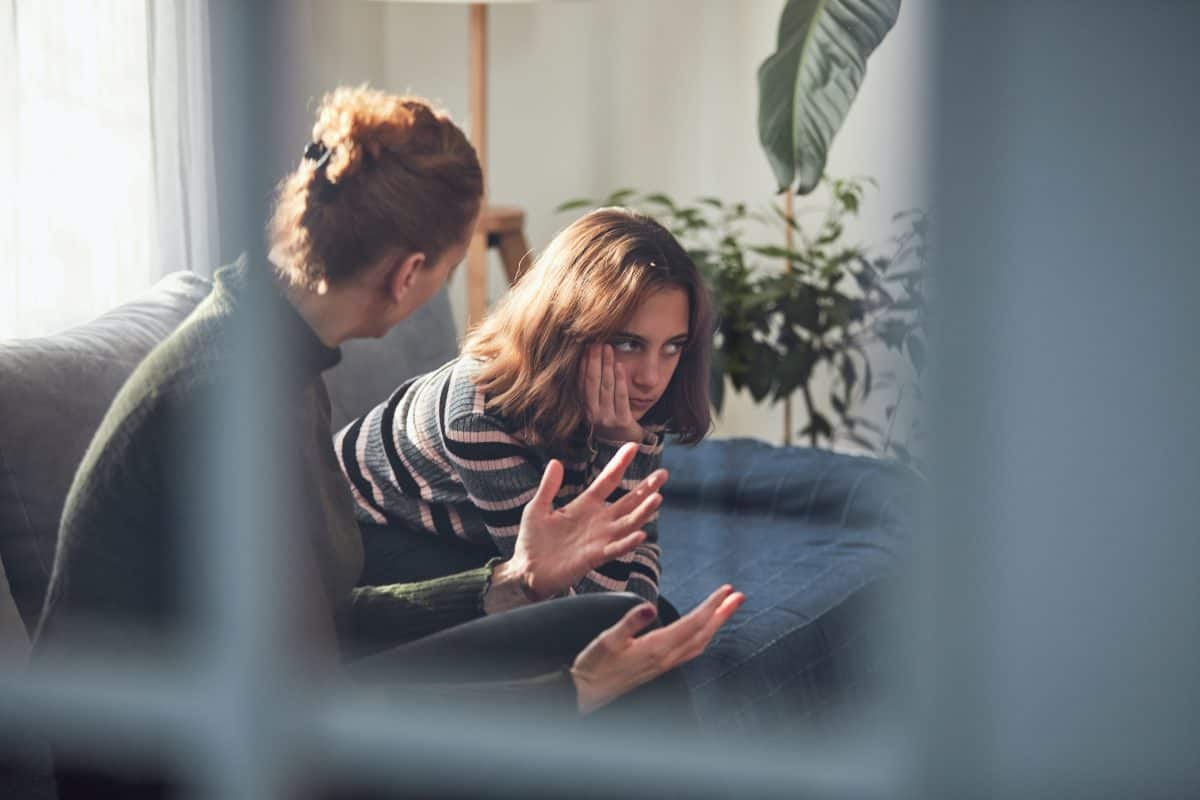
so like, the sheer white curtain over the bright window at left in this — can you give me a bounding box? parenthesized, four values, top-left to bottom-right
(0, 0, 217, 338)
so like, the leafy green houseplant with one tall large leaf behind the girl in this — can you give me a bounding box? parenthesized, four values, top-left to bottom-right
(559, 0, 912, 463)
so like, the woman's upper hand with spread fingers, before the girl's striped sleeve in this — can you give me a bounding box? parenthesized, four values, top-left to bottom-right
(488, 444, 667, 613)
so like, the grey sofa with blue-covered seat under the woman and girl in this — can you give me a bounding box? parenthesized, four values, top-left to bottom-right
(0, 272, 917, 782)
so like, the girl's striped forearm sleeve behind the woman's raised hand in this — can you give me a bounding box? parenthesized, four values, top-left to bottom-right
(575, 431, 662, 603)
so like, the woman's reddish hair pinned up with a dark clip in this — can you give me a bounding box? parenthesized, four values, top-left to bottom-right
(269, 85, 484, 287)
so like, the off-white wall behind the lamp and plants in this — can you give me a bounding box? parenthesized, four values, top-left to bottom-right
(275, 0, 931, 441)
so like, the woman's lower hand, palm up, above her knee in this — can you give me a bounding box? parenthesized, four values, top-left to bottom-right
(571, 585, 745, 714)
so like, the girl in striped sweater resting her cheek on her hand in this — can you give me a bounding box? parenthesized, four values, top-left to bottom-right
(335, 209, 712, 602)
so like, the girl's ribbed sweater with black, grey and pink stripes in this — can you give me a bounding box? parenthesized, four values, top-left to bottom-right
(334, 357, 662, 602)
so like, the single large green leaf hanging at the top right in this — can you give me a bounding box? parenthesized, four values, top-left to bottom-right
(758, 0, 900, 194)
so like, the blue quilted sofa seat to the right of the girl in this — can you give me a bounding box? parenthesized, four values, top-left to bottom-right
(659, 439, 919, 733)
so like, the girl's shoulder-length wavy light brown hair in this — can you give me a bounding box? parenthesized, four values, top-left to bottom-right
(463, 207, 713, 450)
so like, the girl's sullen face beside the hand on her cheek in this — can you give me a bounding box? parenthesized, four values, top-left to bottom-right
(608, 287, 690, 419)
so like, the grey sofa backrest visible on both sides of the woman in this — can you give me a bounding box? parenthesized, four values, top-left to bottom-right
(0, 272, 457, 649)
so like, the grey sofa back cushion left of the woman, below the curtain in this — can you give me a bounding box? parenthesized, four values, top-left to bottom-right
(0, 272, 209, 630)
